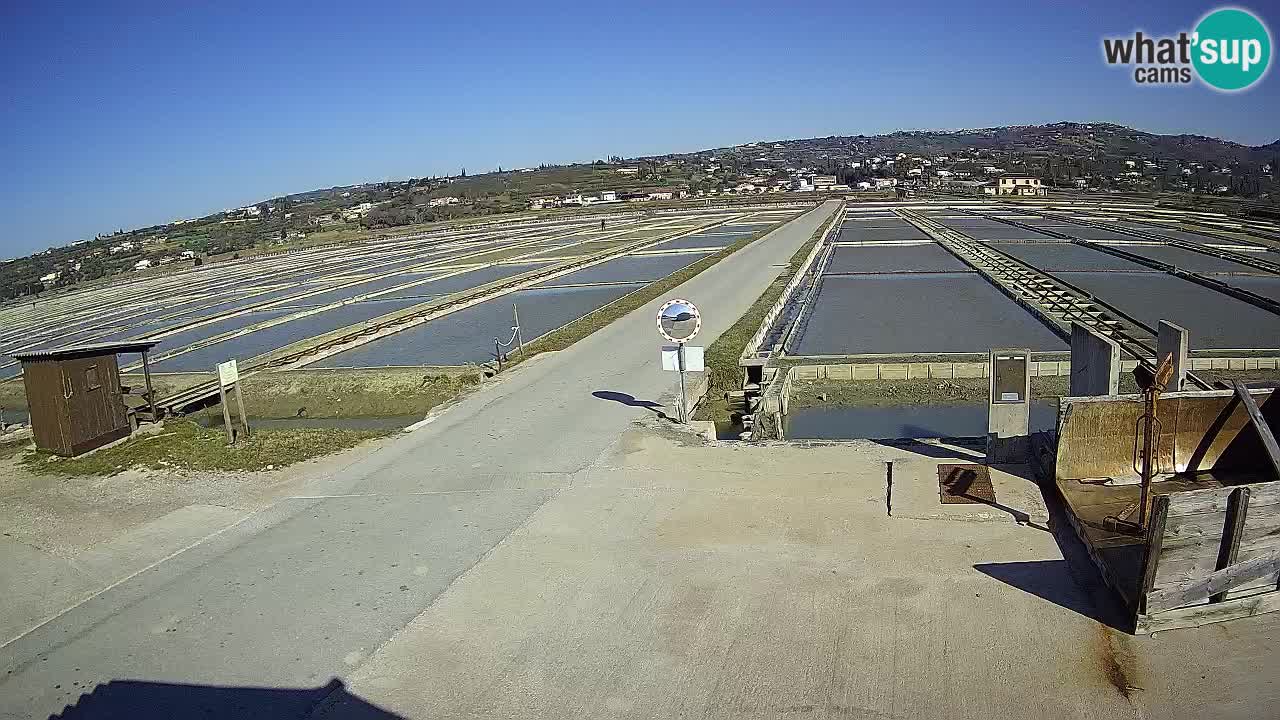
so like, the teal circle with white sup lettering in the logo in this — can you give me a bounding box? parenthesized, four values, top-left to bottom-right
(1192, 8, 1271, 91)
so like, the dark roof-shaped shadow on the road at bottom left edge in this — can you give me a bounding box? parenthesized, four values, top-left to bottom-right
(50, 678, 403, 720)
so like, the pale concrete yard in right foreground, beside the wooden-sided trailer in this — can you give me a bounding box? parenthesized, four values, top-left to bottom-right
(317, 428, 1280, 720)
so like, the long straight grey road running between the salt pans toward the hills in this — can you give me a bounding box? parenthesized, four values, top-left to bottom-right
(0, 202, 837, 717)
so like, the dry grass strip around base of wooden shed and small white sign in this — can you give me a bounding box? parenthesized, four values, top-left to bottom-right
(22, 420, 390, 475)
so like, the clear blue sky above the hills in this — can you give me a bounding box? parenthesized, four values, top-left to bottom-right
(0, 0, 1280, 256)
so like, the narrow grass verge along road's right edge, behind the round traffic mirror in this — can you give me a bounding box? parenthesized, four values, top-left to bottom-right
(698, 207, 836, 423)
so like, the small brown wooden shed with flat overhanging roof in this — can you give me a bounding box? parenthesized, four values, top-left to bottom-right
(14, 341, 156, 457)
